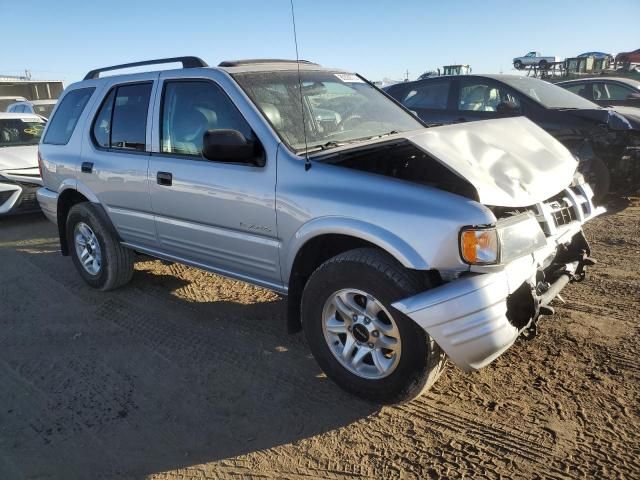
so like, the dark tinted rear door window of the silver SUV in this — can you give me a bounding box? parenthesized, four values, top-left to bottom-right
(93, 83, 152, 152)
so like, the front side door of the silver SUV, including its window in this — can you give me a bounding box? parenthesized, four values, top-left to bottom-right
(149, 74, 282, 288)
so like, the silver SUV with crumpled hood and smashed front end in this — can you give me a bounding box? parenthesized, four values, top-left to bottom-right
(37, 57, 603, 402)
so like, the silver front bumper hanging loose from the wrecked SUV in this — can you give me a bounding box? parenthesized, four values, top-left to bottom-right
(392, 185, 605, 371)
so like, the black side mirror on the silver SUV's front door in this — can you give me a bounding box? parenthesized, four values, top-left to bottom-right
(202, 129, 264, 167)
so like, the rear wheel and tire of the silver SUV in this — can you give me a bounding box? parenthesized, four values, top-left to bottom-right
(66, 202, 134, 291)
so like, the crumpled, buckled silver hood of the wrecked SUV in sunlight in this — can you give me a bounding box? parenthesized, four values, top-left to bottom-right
(405, 117, 577, 207)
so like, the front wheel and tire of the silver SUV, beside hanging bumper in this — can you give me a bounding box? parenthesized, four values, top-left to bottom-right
(302, 248, 446, 403)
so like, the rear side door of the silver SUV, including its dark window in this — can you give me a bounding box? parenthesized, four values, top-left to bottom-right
(78, 72, 158, 247)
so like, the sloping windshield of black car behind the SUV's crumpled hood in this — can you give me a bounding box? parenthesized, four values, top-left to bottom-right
(500, 76, 600, 109)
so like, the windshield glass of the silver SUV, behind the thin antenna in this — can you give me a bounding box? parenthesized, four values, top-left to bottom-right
(234, 71, 423, 152)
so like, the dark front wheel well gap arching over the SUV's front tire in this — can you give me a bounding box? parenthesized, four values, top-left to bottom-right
(287, 234, 438, 333)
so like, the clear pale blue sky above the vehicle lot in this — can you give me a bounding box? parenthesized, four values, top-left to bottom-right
(0, 0, 640, 84)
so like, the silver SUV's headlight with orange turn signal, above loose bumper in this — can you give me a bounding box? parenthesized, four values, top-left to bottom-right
(460, 212, 547, 265)
